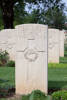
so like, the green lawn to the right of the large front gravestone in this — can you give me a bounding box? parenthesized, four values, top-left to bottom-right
(48, 64, 67, 89)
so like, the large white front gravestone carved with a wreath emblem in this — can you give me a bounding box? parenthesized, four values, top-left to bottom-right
(15, 24, 48, 94)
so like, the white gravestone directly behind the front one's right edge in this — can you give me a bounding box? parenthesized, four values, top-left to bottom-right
(48, 29, 59, 63)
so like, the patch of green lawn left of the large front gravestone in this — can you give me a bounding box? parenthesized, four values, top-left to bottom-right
(0, 67, 15, 87)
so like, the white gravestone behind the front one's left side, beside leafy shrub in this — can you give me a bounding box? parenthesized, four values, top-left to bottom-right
(0, 29, 17, 60)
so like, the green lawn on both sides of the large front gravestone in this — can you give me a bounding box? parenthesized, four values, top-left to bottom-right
(0, 63, 67, 91)
